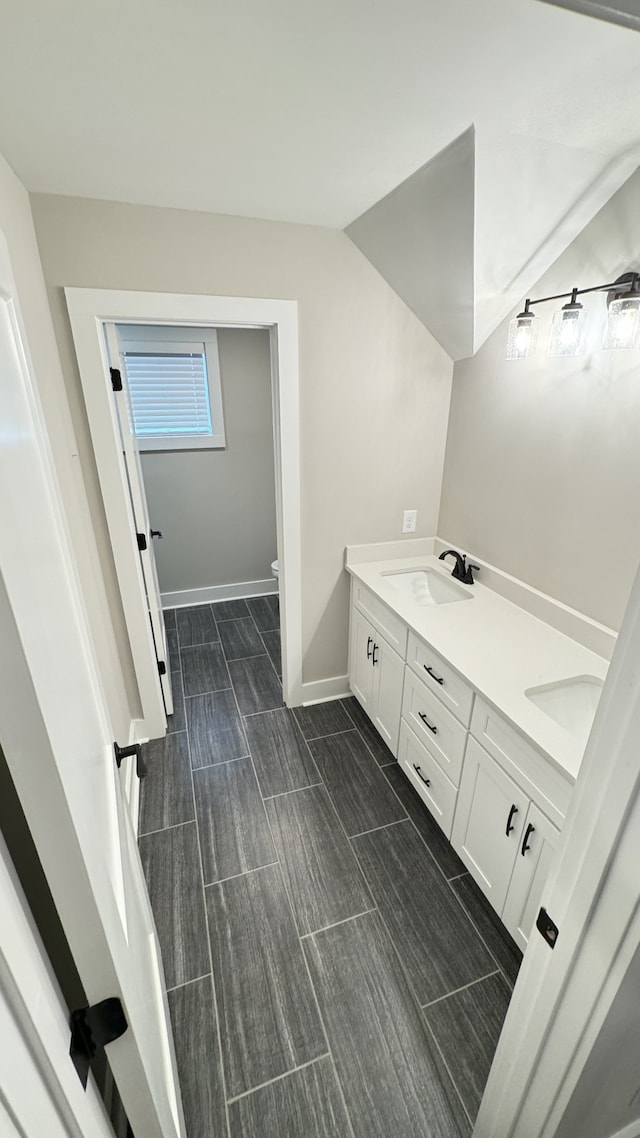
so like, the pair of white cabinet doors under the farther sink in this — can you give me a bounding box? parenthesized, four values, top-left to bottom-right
(348, 607, 404, 754)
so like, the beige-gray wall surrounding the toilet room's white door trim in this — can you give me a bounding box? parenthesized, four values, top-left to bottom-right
(32, 195, 452, 682)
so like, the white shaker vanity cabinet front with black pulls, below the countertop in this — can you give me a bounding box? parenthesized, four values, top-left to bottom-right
(348, 576, 573, 950)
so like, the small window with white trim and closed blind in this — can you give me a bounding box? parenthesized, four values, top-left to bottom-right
(117, 324, 224, 451)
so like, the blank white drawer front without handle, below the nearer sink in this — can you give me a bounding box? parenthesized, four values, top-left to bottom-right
(471, 696, 573, 828)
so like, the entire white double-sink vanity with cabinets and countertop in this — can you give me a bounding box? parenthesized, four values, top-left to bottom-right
(346, 541, 614, 950)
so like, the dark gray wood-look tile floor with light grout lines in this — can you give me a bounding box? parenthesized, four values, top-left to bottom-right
(140, 596, 512, 1138)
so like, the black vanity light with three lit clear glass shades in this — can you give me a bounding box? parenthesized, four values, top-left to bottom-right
(507, 272, 640, 360)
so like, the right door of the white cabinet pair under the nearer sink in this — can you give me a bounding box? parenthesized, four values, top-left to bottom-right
(502, 802, 560, 953)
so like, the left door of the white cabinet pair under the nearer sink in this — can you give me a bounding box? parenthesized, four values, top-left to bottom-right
(451, 739, 530, 914)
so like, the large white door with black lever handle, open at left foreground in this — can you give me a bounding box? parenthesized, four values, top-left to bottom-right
(0, 237, 184, 1138)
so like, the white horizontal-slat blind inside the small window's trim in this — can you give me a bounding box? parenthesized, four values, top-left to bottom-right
(125, 346, 213, 439)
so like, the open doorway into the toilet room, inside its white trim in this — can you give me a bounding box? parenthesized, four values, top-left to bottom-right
(116, 324, 282, 726)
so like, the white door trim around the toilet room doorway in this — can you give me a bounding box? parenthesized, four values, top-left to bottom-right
(65, 288, 302, 739)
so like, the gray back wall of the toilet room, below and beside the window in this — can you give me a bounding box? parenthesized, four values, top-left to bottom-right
(142, 329, 277, 593)
